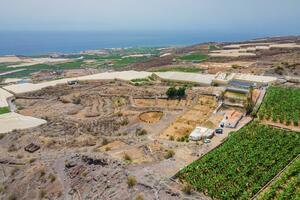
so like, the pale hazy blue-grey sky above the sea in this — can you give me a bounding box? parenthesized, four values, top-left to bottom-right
(0, 0, 300, 34)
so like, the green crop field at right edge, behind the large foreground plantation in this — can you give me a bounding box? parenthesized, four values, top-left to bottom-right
(258, 87, 300, 126)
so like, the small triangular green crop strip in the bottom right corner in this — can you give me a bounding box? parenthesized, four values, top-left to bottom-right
(258, 158, 300, 200)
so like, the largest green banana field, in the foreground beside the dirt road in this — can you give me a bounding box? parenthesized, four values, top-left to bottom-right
(177, 121, 300, 199)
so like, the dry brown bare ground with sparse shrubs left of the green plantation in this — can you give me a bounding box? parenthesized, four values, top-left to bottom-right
(0, 81, 214, 200)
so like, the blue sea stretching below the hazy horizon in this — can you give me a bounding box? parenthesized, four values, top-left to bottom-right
(0, 31, 274, 56)
